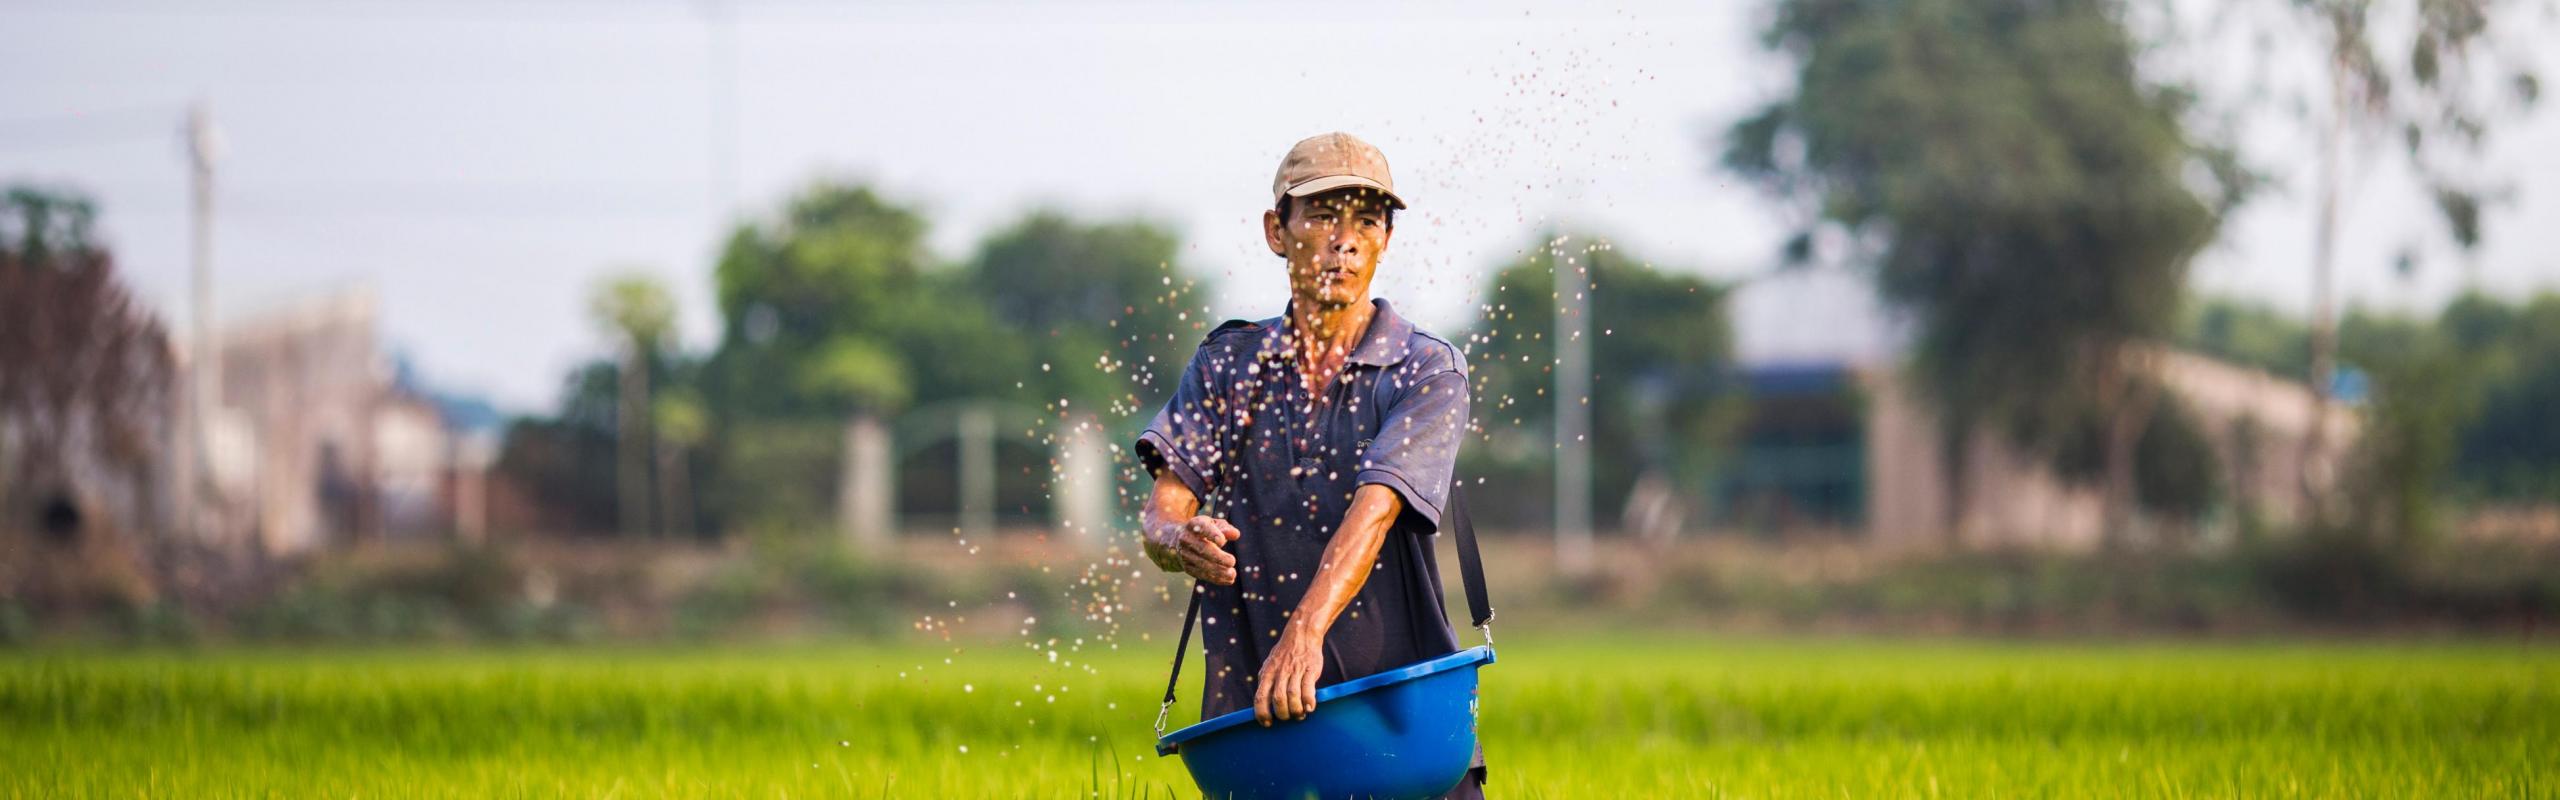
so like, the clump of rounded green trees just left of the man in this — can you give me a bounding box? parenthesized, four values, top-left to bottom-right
(704, 185, 1206, 526)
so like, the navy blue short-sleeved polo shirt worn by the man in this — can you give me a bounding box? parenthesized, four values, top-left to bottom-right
(1137, 300, 1467, 721)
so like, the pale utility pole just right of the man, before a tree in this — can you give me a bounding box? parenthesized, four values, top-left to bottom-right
(1546, 236, 1592, 574)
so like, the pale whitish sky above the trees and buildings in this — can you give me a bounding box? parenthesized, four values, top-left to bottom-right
(0, 0, 2560, 413)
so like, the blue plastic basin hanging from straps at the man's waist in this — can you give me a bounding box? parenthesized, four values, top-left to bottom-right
(1155, 646, 1492, 800)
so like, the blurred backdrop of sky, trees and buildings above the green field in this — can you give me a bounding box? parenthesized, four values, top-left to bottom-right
(0, 0, 2560, 644)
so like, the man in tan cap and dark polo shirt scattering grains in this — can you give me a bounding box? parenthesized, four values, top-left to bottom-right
(1137, 133, 1485, 797)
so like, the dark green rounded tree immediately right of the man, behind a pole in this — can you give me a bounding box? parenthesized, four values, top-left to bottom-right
(1462, 236, 1743, 533)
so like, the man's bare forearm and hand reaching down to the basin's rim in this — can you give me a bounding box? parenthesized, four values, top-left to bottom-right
(1254, 476, 1405, 726)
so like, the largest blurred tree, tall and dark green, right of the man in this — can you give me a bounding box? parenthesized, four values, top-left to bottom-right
(1723, 0, 2248, 543)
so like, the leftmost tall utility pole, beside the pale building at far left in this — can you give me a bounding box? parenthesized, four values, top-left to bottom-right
(169, 100, 223, 536)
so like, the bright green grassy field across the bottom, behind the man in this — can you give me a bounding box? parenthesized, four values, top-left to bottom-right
(0, 631, 2560, 797)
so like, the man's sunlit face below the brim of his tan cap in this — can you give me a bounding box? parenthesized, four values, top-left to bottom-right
(1262, 187, 1393, 308)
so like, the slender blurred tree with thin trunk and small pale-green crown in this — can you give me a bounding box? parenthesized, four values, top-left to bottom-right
(589, 272, 676, 536)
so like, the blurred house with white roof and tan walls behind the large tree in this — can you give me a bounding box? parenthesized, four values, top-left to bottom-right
(1710, 272, 2358, 549)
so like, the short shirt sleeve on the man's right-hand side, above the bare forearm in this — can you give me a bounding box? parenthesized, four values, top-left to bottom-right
(1354, 344, 1467, 533)
